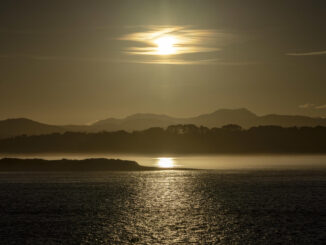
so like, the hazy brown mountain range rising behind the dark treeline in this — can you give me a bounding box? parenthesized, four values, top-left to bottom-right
(0, 108, 326, 138)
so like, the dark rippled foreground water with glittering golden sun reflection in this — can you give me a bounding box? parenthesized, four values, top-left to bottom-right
(0, 170, 326, 245)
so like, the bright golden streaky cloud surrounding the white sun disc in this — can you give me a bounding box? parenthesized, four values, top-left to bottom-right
(118, 26, 233, 64)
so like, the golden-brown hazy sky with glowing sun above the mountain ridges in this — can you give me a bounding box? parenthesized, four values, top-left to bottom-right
(0, 0, 326, 124)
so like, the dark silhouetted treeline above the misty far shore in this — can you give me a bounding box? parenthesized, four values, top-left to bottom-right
(0, 125, 326, 153)
